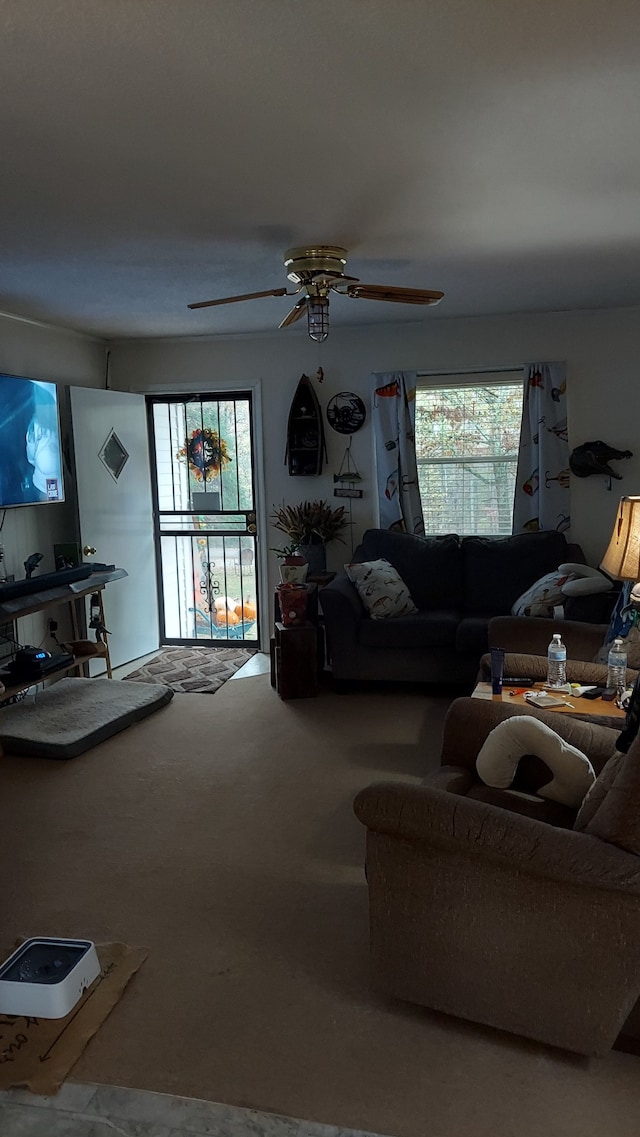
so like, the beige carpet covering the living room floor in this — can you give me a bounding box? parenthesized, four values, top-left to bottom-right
(0, 675, 640, 1137)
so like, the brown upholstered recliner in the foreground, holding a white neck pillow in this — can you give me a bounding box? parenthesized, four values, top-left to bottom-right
(355, 698, 640, 1054)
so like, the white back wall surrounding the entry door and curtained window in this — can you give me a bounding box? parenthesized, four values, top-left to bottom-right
(111, 308, 640, 579)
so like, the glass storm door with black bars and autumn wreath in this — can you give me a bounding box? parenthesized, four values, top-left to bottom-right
(148, 392, 259, 647)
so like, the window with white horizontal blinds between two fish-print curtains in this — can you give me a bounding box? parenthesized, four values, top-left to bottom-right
(416, 371, 524, 537)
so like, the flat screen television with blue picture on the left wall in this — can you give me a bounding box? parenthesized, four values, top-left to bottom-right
(0, 372, 65, 509)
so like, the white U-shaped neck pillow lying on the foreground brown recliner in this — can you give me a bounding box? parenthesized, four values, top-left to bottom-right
(475, 715, 596, 810)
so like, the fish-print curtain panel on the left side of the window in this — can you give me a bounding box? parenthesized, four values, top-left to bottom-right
(372, 371, 424, 534)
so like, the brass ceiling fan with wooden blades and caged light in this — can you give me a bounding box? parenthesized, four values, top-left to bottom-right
(188, 244, 444, 342)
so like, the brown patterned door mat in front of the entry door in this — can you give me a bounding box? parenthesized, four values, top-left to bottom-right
(125, 647, 256, 695)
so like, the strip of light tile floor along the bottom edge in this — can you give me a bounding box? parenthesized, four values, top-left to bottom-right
(0, 1081, 388, 1137)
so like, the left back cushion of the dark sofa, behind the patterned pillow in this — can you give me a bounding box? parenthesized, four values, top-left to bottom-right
(361, 529, 463, 609)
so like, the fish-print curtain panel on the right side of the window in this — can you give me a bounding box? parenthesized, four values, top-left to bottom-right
(514, 363, 571, 538)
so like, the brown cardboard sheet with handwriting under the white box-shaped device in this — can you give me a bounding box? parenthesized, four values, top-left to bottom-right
(0, 940, 149, 1094)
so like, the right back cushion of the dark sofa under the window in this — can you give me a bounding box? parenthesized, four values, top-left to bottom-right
(462, 530, 567, 616)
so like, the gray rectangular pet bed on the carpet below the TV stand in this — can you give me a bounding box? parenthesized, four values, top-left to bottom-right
(0, 679, 174, 758)
